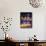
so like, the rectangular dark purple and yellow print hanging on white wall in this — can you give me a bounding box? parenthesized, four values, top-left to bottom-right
(20, 12, 32, 28)
